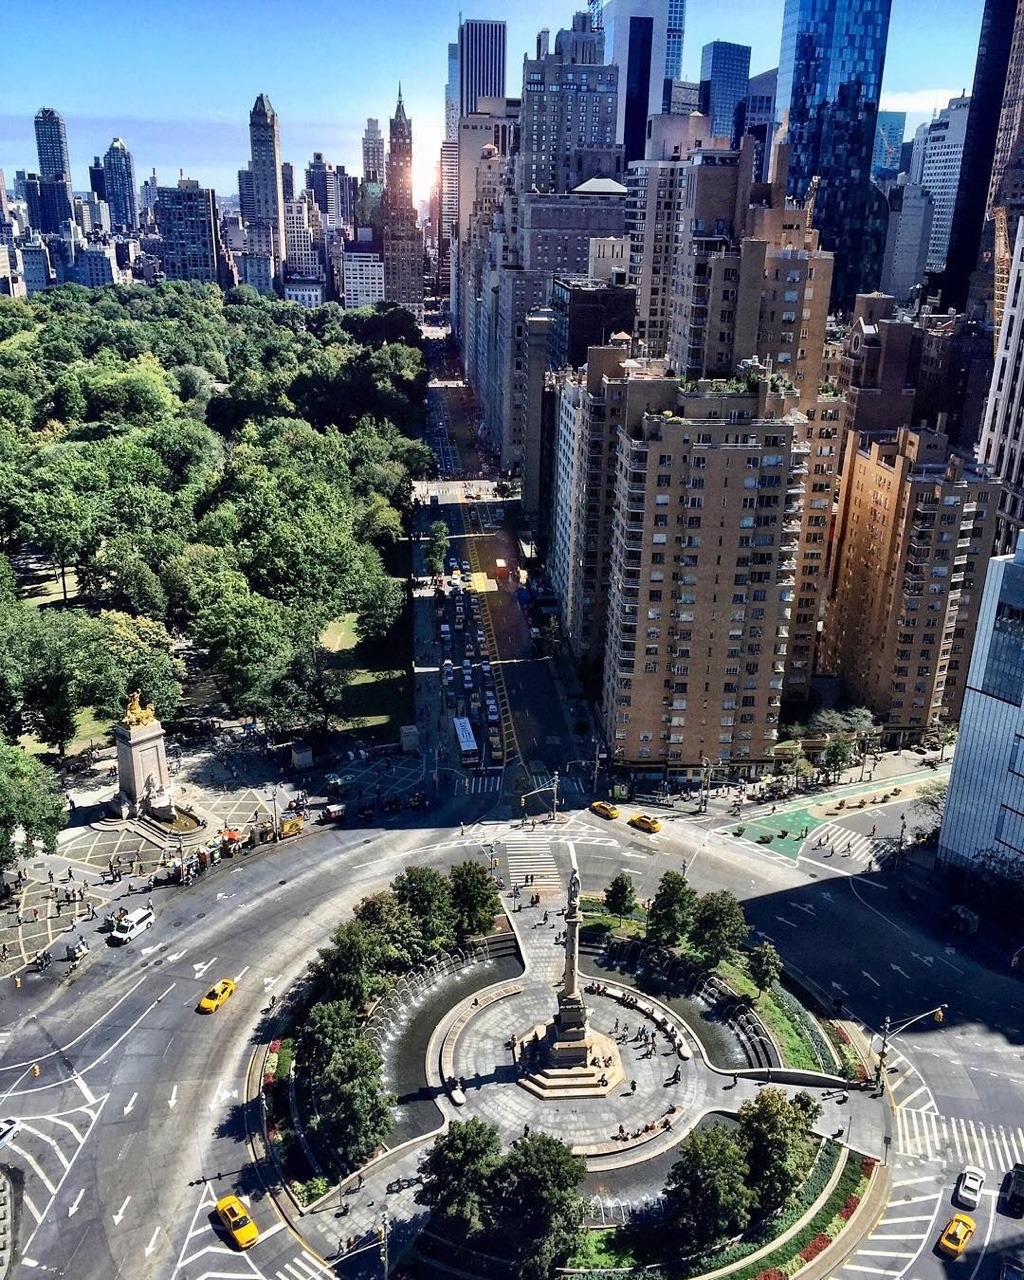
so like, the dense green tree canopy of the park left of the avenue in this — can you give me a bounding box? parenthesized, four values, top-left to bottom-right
(0, 283, 434, 750)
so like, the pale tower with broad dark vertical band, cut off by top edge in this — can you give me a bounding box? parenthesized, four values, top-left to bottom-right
(588, 0, 685, 164)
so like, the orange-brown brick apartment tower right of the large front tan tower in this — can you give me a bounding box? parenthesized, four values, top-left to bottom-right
(820, 428, 998, 745)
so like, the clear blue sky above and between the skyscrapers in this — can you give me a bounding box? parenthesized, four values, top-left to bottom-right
(0, 0, 982, 198)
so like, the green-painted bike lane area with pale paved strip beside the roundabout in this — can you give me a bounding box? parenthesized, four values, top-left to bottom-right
(714, 762, 950, 861)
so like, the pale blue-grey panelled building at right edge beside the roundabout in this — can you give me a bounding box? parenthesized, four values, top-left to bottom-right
(938, 529, 1024, 884)
